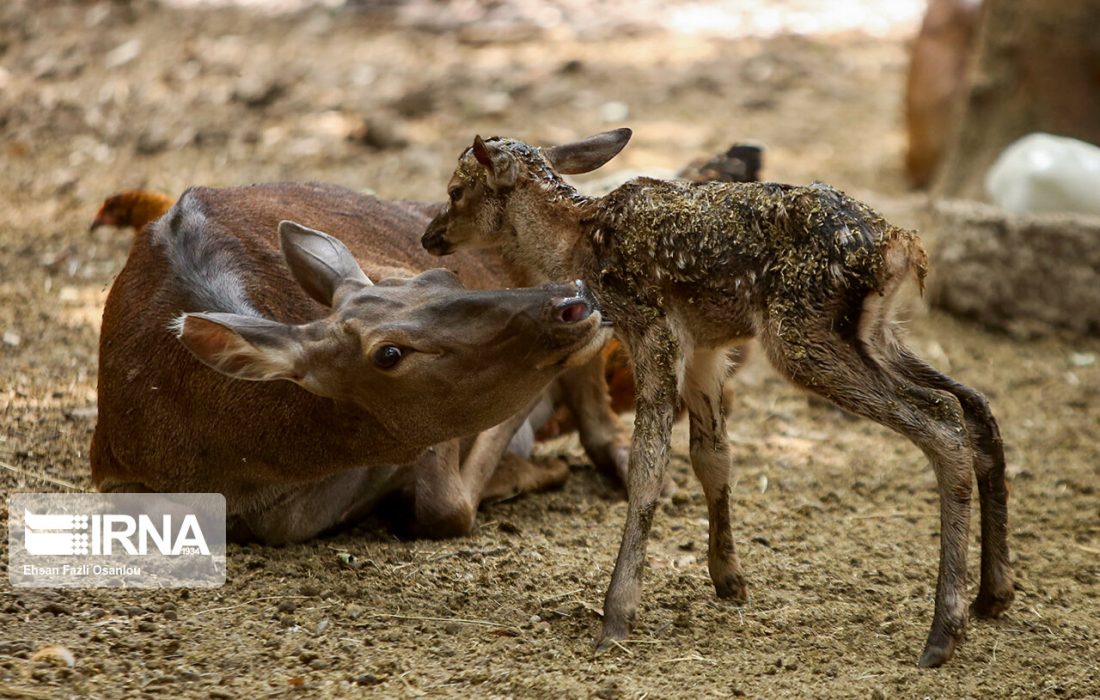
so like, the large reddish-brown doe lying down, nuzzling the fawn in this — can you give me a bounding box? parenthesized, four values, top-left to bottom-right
(90, 184, 609, 544)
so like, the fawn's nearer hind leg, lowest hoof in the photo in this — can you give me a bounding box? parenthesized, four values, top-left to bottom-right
(760, 318, 974, 666)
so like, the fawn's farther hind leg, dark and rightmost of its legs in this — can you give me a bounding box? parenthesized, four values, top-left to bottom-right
(891, 346, 1015, 617)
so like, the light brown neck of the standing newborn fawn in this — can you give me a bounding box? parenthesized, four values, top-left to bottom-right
(503, 183, 593, 282)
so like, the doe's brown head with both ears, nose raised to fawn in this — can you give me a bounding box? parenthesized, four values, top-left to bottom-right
(176, 221, 606, 446)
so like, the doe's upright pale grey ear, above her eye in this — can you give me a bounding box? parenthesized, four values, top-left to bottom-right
(278, 221, 372, 306)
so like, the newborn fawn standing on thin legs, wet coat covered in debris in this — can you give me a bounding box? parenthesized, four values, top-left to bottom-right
(424, 129, 1013, 666)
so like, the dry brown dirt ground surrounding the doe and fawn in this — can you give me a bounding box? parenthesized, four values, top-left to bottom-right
(0, 0, 1100, 698)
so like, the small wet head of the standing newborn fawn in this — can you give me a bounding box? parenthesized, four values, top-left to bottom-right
(420, 129, 630, 255)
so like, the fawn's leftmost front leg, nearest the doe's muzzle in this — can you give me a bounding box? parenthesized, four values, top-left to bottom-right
(596, 320, 683, 649)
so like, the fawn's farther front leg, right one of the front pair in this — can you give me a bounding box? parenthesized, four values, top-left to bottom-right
(683, 348, 748, 603)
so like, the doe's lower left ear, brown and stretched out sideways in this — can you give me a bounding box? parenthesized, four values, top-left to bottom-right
(175, 314, 305, 382)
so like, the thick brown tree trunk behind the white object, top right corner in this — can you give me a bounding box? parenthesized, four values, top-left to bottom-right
(936, 0, 1100, 199)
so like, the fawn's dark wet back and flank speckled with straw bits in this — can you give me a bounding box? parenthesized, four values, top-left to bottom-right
(586, 178, 912, 298)
